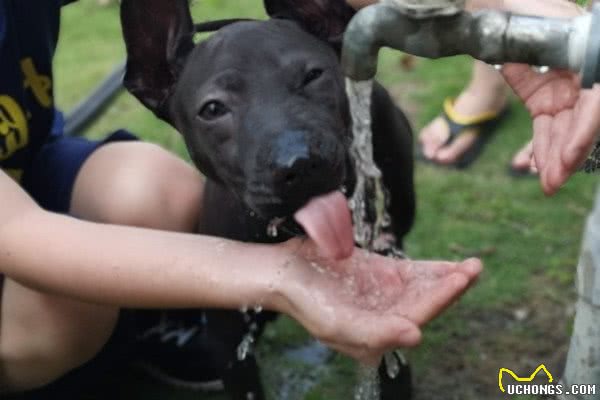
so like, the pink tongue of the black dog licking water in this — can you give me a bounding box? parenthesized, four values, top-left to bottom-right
(294, 191, 354, 260)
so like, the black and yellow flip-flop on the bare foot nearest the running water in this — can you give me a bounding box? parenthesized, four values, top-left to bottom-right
(417, 98, 508, 169)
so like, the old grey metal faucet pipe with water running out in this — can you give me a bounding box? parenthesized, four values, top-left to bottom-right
(342, 0, 600, 88)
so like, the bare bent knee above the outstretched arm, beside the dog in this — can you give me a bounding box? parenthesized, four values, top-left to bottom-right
(72, 143, 202, 231)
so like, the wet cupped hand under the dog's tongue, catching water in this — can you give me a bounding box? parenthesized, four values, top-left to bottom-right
(280, 239, 482, 364)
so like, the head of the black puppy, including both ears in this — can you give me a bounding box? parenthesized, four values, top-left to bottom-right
(121, 0, 352, 217)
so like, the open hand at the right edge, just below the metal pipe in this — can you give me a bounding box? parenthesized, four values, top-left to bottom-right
(503, 64, 600, 195)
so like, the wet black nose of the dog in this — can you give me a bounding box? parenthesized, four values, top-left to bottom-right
(273, 131, 333, 195)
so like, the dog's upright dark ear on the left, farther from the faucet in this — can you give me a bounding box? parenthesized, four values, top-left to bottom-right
(121, 0, 194, 119)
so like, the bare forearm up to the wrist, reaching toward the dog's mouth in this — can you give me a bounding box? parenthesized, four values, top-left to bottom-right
(0, 206, 286, 308)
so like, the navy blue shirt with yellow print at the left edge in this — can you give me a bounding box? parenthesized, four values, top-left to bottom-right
(0, 0, 63, 180)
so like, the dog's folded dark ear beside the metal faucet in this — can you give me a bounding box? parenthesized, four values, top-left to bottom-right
(264, 0, 355, 47)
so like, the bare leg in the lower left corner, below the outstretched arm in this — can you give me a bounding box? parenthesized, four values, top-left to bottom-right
(0, 284, 119, 391)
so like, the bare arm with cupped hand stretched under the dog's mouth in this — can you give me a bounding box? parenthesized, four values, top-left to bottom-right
(0, 171, 481, 362)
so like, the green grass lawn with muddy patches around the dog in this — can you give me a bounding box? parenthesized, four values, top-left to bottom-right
(55, 0, 596, 400)
